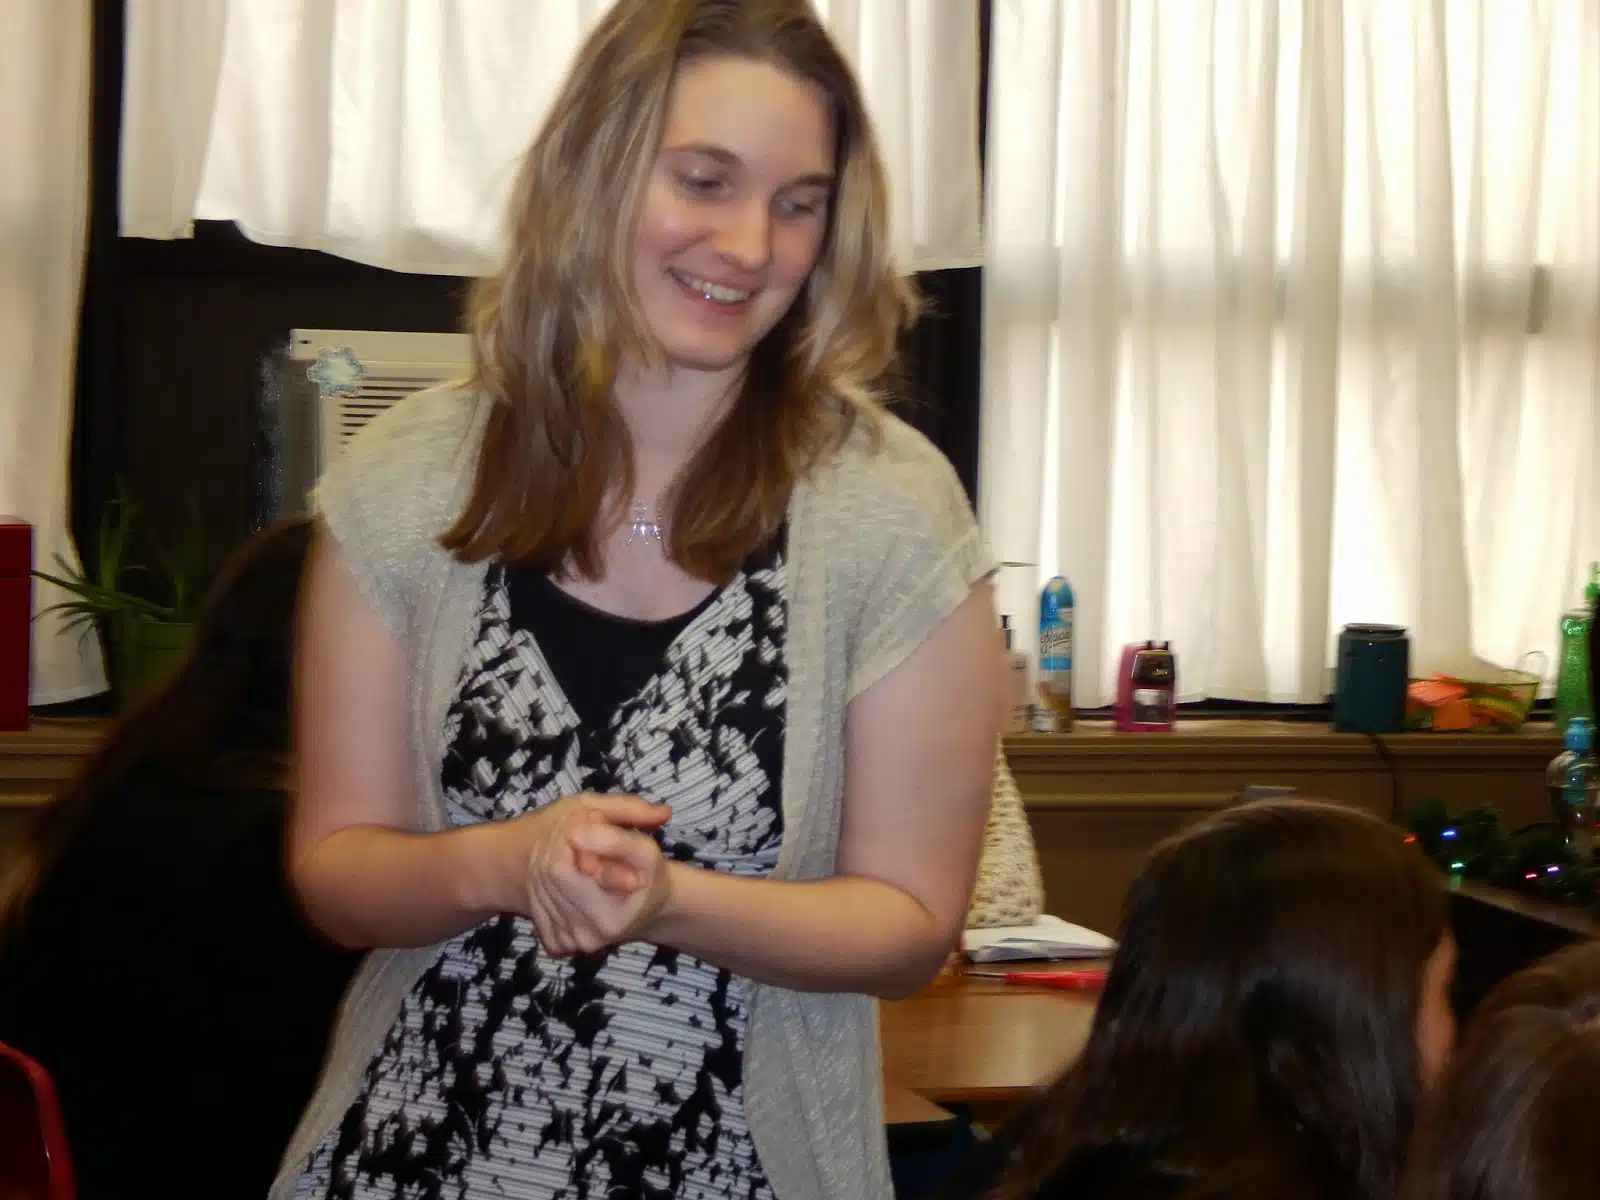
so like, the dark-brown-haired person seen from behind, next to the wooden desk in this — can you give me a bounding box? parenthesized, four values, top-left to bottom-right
(968, 802, 1454, 1200)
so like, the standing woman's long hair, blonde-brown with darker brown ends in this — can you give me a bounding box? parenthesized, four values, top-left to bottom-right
(442, 0, 915, 582)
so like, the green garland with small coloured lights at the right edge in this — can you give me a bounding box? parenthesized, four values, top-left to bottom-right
(1405, 800, 1600, 917)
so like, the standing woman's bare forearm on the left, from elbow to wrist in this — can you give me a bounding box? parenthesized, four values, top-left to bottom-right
(291, 824, 509, 949)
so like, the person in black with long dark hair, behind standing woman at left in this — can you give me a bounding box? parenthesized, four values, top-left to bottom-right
(0, 520, 355, 1200)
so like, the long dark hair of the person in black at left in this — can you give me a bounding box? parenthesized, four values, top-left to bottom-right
(0, 518, 312, 936)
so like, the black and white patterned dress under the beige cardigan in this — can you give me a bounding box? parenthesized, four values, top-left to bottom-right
(296, 538, 787, 1200)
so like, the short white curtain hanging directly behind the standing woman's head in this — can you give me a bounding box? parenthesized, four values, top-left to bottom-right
(122, 0, 981, 275)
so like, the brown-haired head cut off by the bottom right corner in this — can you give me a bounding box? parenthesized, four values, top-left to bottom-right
(1402, 942, 1600, 1200)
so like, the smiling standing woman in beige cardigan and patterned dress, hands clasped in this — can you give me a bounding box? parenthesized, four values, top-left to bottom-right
(274, 0, 1000, 1200)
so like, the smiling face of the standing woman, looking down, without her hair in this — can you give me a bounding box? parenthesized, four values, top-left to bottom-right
(634, 56, 835, 371)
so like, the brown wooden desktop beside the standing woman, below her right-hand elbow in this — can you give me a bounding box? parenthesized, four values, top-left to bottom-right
(878, 963, 1096, 1117)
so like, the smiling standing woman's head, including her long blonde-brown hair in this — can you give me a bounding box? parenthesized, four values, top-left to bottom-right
(446, 0, 914, 578)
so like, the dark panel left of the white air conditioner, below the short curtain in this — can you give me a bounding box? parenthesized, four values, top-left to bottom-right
(74, 233, 462, 579)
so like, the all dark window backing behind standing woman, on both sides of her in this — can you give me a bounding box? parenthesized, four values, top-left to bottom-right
(72, 0, 981, 582)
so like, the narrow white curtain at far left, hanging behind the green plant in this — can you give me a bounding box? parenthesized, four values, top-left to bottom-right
(0, 0, 106, 704)
